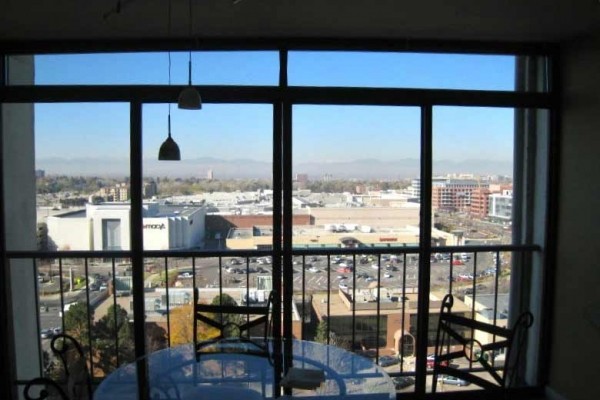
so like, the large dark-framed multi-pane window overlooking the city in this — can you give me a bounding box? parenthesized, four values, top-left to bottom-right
(2, 47, 550, 394)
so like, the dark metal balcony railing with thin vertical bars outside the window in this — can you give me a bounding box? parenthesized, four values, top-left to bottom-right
(8, 245, 539, 391)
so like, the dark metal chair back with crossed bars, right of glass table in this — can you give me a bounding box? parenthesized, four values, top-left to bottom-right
(432, 294, 533, 392)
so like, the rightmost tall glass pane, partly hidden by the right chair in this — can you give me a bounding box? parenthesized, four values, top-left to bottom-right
(428, 107, 516, 391)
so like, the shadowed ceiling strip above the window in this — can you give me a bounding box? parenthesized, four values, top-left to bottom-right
(0, 0, 600, 42)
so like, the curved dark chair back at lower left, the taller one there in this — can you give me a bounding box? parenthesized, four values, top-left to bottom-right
(50, 333, 92, 400)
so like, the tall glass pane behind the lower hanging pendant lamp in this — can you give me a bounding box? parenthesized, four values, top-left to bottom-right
(143, 104, 273, 352)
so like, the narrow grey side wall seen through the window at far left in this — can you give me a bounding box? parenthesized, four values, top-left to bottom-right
(2, 56, 41, 379)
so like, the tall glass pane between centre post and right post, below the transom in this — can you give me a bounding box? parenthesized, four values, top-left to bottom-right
(292, 106, 420, 391)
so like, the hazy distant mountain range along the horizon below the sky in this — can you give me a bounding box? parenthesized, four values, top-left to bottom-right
(35, 157, 513, 179)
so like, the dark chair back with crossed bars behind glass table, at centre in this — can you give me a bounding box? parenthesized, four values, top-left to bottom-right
(193, 288, 273, 357)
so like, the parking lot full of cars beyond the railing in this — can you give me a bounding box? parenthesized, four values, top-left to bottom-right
(162, 253, 504, 293)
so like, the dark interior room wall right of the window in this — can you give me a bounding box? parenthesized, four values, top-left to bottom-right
(549, 33, 600, 400)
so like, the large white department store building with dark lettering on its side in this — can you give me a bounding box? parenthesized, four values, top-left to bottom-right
(47, 203, 206, 250)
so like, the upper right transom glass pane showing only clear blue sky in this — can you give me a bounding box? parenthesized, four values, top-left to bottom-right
(289, 51, 515, 91)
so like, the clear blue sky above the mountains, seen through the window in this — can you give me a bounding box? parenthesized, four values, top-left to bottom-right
(36, 52, 514, 173)
